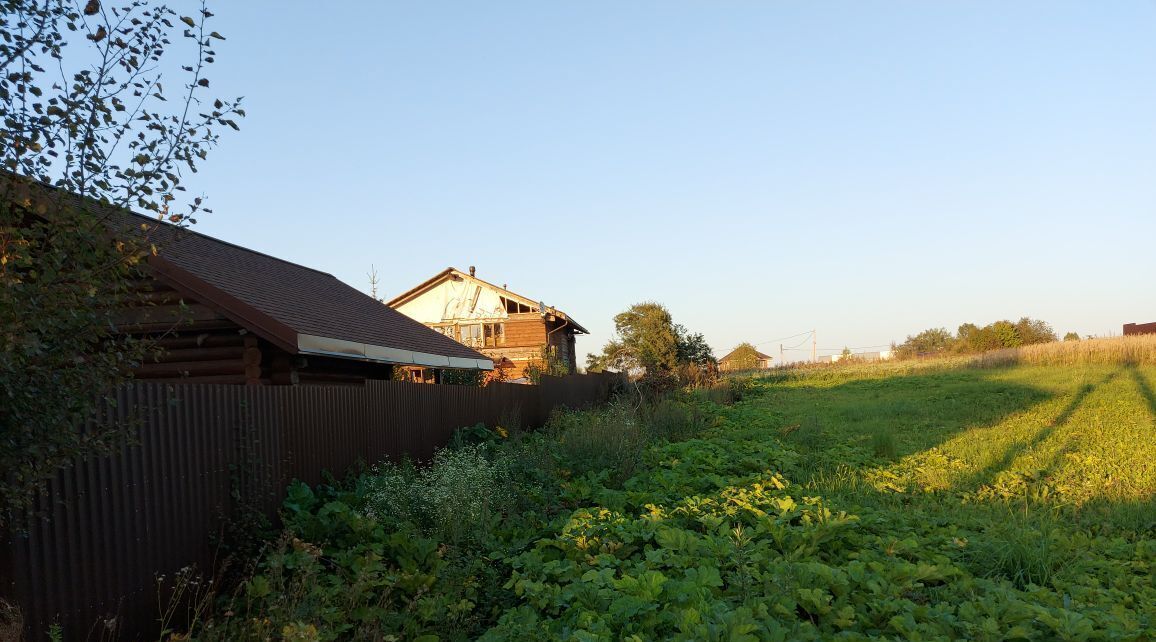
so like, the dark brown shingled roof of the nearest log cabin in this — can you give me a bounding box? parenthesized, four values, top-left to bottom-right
(10, 175, 494, 370)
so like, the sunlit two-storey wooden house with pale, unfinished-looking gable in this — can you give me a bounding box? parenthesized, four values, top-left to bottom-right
(387, 267, 590, 379)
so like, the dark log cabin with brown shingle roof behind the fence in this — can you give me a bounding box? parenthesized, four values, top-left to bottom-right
(9, 174, 494, 385)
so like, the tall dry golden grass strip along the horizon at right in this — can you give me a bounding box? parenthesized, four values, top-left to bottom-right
(969, 334, 1156, 368)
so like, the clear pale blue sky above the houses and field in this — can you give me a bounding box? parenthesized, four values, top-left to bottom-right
(180, 0, 1156, 355)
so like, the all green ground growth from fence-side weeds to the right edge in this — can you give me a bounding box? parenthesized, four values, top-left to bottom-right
(184, 358, 1156, 640)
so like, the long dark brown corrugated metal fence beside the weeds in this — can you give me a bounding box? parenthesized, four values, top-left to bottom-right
(0, 375, 620, 640)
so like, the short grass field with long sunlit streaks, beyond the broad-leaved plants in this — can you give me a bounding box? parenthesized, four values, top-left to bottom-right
(767, 366, 1156, 529)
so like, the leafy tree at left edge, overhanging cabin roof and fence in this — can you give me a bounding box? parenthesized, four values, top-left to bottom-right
(0, 0, 244, 519)
